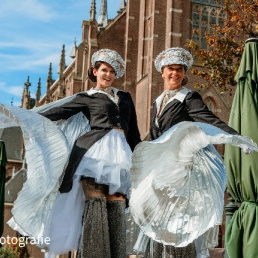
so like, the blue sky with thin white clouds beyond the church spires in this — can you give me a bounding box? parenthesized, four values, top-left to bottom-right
(0, 0, 121, 106)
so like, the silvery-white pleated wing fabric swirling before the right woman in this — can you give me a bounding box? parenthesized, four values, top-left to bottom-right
(130, 122, 258, 251)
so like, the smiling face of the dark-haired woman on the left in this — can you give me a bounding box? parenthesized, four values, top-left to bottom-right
(93, 63, 116, 89)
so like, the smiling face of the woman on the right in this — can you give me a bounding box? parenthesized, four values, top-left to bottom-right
(162, 64, 185, 90)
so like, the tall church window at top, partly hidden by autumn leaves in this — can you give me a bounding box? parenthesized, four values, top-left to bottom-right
(192, 0, 224, 49)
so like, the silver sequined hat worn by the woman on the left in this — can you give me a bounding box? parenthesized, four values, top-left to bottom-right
(91, 49, 125, 78)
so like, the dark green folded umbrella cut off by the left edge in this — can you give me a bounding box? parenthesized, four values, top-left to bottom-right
(0, 140, 7, 236)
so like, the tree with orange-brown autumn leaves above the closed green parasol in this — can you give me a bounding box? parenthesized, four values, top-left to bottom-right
(187, 0, 258, 92)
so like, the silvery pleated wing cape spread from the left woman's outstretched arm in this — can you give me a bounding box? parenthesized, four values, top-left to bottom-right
(0, 103, 90, 248)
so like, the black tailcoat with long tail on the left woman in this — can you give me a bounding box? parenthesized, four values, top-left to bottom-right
(41, 90, 141, 192)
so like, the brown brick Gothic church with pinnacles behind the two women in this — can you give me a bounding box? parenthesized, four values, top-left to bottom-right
(7, 0, 238, 256)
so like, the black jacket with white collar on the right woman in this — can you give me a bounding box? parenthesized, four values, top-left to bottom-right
(150, 88, 238, 140)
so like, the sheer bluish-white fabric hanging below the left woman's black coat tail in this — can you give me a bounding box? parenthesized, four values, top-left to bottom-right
(43, 176, 85, 255)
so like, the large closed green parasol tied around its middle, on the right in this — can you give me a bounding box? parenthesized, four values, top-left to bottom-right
(225, 39, 258, 258)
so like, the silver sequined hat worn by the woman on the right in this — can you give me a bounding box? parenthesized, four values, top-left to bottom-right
(154, 47, 193, 73)
